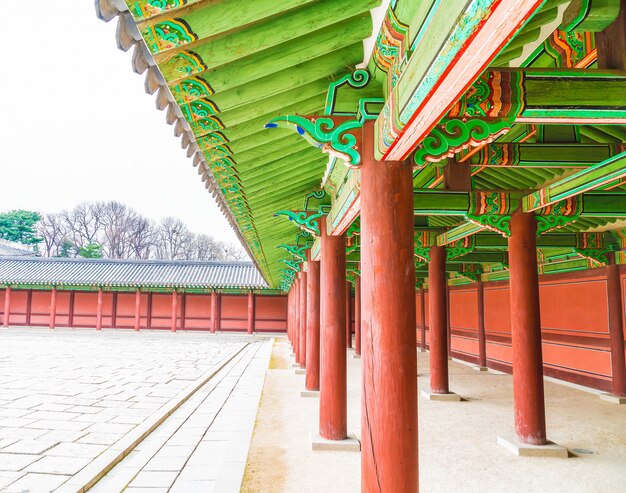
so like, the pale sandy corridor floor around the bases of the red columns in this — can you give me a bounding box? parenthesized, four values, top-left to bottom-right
(242, 339, 626, 493)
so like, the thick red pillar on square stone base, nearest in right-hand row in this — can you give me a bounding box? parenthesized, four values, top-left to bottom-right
(509, 212, 546, 445)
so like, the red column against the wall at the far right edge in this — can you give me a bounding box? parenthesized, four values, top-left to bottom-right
(606, 258, 626, 397)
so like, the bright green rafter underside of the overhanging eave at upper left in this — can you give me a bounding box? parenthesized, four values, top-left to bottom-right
(116, 0, 380, 287)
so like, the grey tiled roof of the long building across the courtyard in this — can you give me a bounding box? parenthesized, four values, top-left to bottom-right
(0, 257, 267, 289)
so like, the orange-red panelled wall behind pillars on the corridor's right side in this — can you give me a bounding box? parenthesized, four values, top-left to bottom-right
(416, 269, 626, 391)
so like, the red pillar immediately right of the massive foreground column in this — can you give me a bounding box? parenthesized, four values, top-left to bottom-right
(428, 246, 450, 394)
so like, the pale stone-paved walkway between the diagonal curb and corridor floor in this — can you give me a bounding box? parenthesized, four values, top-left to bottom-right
(90, 340, 272, 493)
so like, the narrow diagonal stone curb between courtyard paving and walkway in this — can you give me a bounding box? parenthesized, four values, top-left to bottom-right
(54, 343, 250, 493)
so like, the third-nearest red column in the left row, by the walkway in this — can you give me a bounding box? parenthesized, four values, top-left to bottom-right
(304, 256, 320, 390)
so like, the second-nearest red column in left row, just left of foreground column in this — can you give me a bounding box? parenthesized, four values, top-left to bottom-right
(320, 218, 348, 440)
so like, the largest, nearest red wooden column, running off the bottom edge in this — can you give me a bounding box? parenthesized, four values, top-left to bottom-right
(361, 122, 418, 493)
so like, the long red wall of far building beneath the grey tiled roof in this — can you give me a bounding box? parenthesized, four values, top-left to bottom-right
(0, 289, 287, 332)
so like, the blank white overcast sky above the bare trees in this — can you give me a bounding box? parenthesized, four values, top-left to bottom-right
(0, 0, 238, 243)
